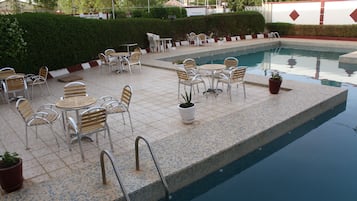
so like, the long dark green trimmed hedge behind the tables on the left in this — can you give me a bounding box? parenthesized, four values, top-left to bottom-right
(0, 12, 264, 73)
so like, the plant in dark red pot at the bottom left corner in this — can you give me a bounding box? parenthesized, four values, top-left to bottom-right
(0, 151, 24, 193)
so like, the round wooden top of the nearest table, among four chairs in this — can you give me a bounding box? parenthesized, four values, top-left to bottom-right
(56, 96, 97, 109)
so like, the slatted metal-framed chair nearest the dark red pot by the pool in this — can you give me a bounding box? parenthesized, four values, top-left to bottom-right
(216, 67, 247, 101)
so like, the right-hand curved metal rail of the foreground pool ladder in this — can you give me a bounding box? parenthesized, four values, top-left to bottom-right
(135, 136, 170, 199)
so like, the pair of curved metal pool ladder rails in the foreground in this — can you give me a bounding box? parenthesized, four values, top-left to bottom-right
(100, 136, 171, 201)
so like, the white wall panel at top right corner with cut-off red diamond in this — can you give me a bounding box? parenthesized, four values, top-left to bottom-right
(324, 1, 357, 25)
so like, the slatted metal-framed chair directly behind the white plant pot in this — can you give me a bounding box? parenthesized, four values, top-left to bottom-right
(176, 69, 206, 99)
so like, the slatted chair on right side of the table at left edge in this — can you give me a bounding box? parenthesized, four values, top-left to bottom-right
(25, 66, 51, 98)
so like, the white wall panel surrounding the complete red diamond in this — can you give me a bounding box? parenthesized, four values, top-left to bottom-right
(272, 2, 321, 24)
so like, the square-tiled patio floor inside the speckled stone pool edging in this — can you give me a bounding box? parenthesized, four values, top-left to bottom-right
(0, 55, 268, 194)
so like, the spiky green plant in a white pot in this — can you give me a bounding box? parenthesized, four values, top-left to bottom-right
(178, 91, 195, 124)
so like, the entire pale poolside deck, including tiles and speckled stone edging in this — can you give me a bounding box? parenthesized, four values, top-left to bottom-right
(0, 39, 350, 200)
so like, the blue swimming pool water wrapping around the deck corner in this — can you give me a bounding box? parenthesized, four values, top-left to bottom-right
(164, 48, 357, 201)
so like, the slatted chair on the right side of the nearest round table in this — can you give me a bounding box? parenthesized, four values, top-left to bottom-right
(99, 85, 134, 133)
